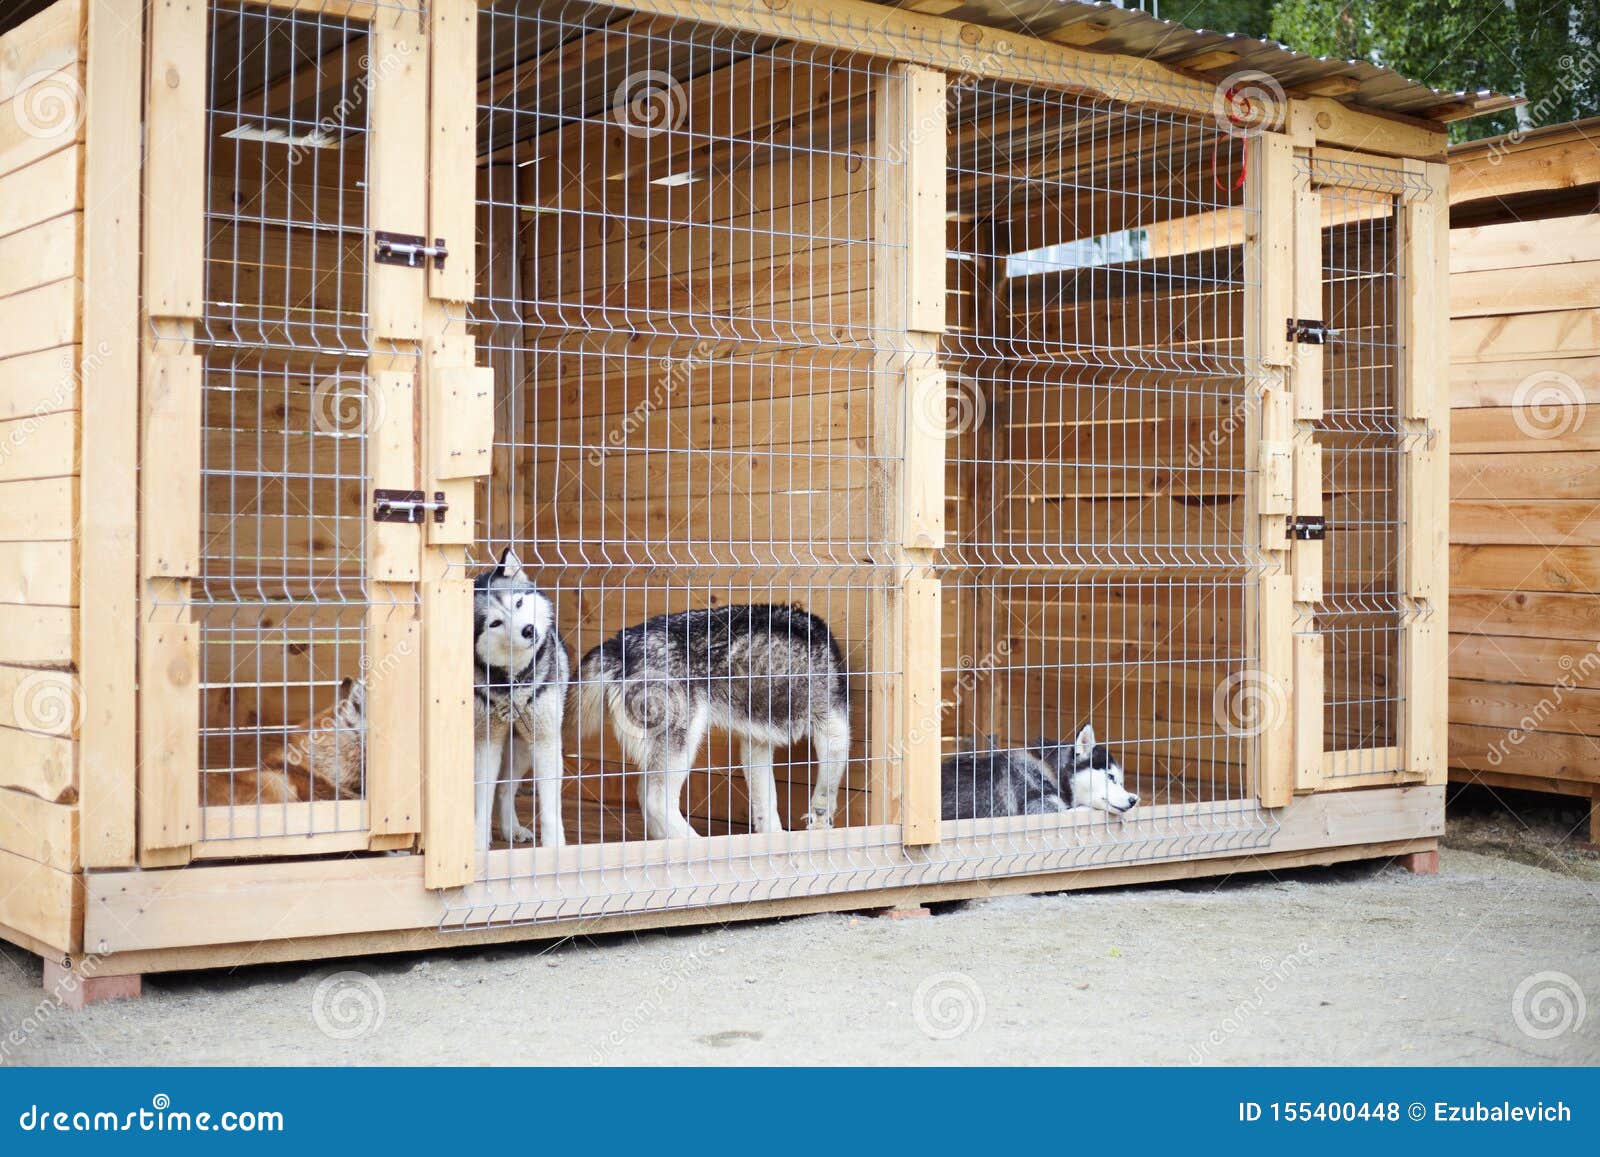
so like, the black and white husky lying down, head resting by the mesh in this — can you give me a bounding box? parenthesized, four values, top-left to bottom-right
(939, 727, 1139, 819)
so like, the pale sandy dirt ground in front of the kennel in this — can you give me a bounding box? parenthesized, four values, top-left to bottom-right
(0, 790, 1600, 1064)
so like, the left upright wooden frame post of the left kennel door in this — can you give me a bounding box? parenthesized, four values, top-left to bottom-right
(137, 0, 208, 867)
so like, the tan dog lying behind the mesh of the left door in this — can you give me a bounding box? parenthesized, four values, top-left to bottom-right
(202, 679, 366, 807)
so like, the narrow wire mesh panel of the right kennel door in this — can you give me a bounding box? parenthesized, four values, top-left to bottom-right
(1298, 160, 1422, 784)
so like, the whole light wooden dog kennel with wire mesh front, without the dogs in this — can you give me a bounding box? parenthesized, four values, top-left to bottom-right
(0, 0, 1494, 976)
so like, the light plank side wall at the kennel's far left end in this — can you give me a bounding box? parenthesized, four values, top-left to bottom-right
(0, 0, 86, 949)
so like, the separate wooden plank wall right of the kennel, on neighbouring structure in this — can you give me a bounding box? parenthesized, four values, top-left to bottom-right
(1450, 199, 1600, 839)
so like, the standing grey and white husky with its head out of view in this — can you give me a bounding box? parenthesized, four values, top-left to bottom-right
(578, 605, 850, 840)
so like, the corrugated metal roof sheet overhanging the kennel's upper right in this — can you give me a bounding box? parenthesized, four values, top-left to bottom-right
(890, 0, 1526, 123)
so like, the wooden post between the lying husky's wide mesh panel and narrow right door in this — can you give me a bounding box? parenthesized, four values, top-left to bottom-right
(1245, 133, 1299, 808)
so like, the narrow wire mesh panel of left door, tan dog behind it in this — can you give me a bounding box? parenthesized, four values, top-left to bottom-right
(180, 0, 393, 855)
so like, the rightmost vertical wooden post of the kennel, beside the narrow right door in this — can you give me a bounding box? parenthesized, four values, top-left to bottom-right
(1397, 162, 1450, 784)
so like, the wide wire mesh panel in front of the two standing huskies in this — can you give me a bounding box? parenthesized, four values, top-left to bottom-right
(453, 0, 906, 923)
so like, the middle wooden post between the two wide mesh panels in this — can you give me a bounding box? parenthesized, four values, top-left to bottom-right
(869, 64, 946, 845)
